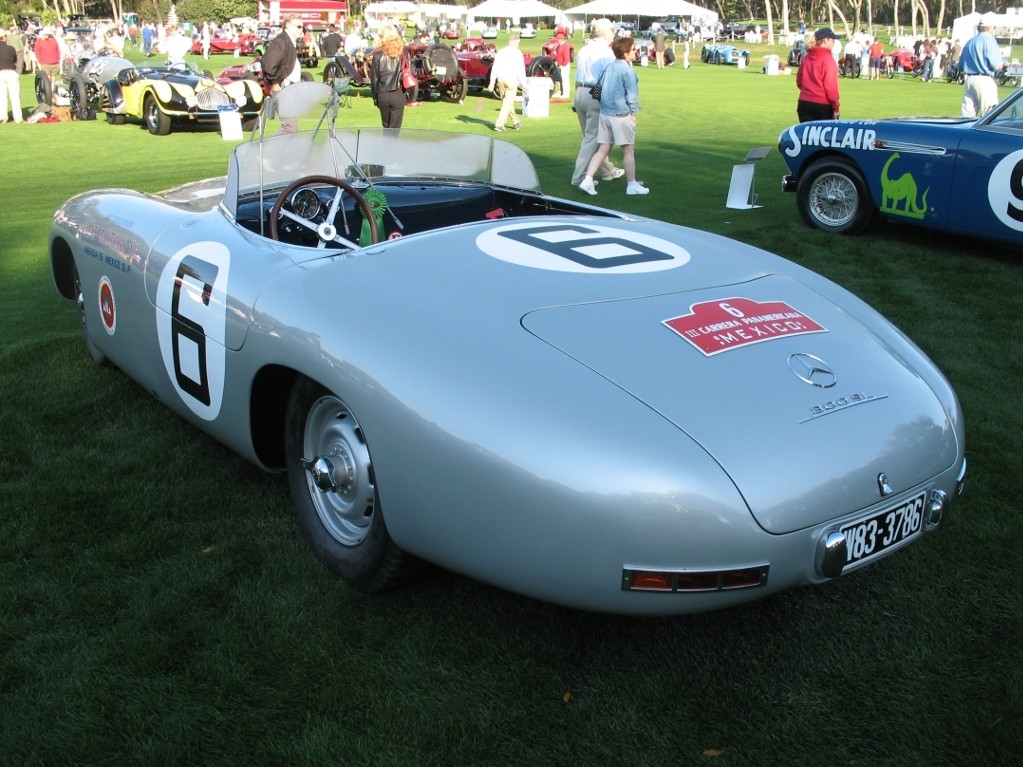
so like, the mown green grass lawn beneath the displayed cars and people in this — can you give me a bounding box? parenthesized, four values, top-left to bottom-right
(0, 41, 1023, 767)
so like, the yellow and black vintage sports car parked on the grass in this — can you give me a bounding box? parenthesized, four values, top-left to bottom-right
(100, 65, 263, 136)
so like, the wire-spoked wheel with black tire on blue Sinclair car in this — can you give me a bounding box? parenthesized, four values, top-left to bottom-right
(796, 157, 877, 234)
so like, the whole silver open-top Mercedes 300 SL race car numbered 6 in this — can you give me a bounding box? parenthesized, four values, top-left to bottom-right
(49, 83, 966, 615)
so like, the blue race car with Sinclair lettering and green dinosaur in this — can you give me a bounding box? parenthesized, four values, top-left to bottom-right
(779, 83, 1023, 243)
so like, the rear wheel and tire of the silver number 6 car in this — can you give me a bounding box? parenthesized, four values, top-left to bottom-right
(284, 377, 413, 593)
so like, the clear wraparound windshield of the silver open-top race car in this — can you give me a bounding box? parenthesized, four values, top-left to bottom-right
(224, 83, 540, 213)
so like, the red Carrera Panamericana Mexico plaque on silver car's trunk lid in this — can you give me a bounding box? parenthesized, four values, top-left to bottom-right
(664, 298, 828, 357)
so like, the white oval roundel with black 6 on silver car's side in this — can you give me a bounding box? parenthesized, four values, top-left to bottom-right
(157, 241, 231, 420)
